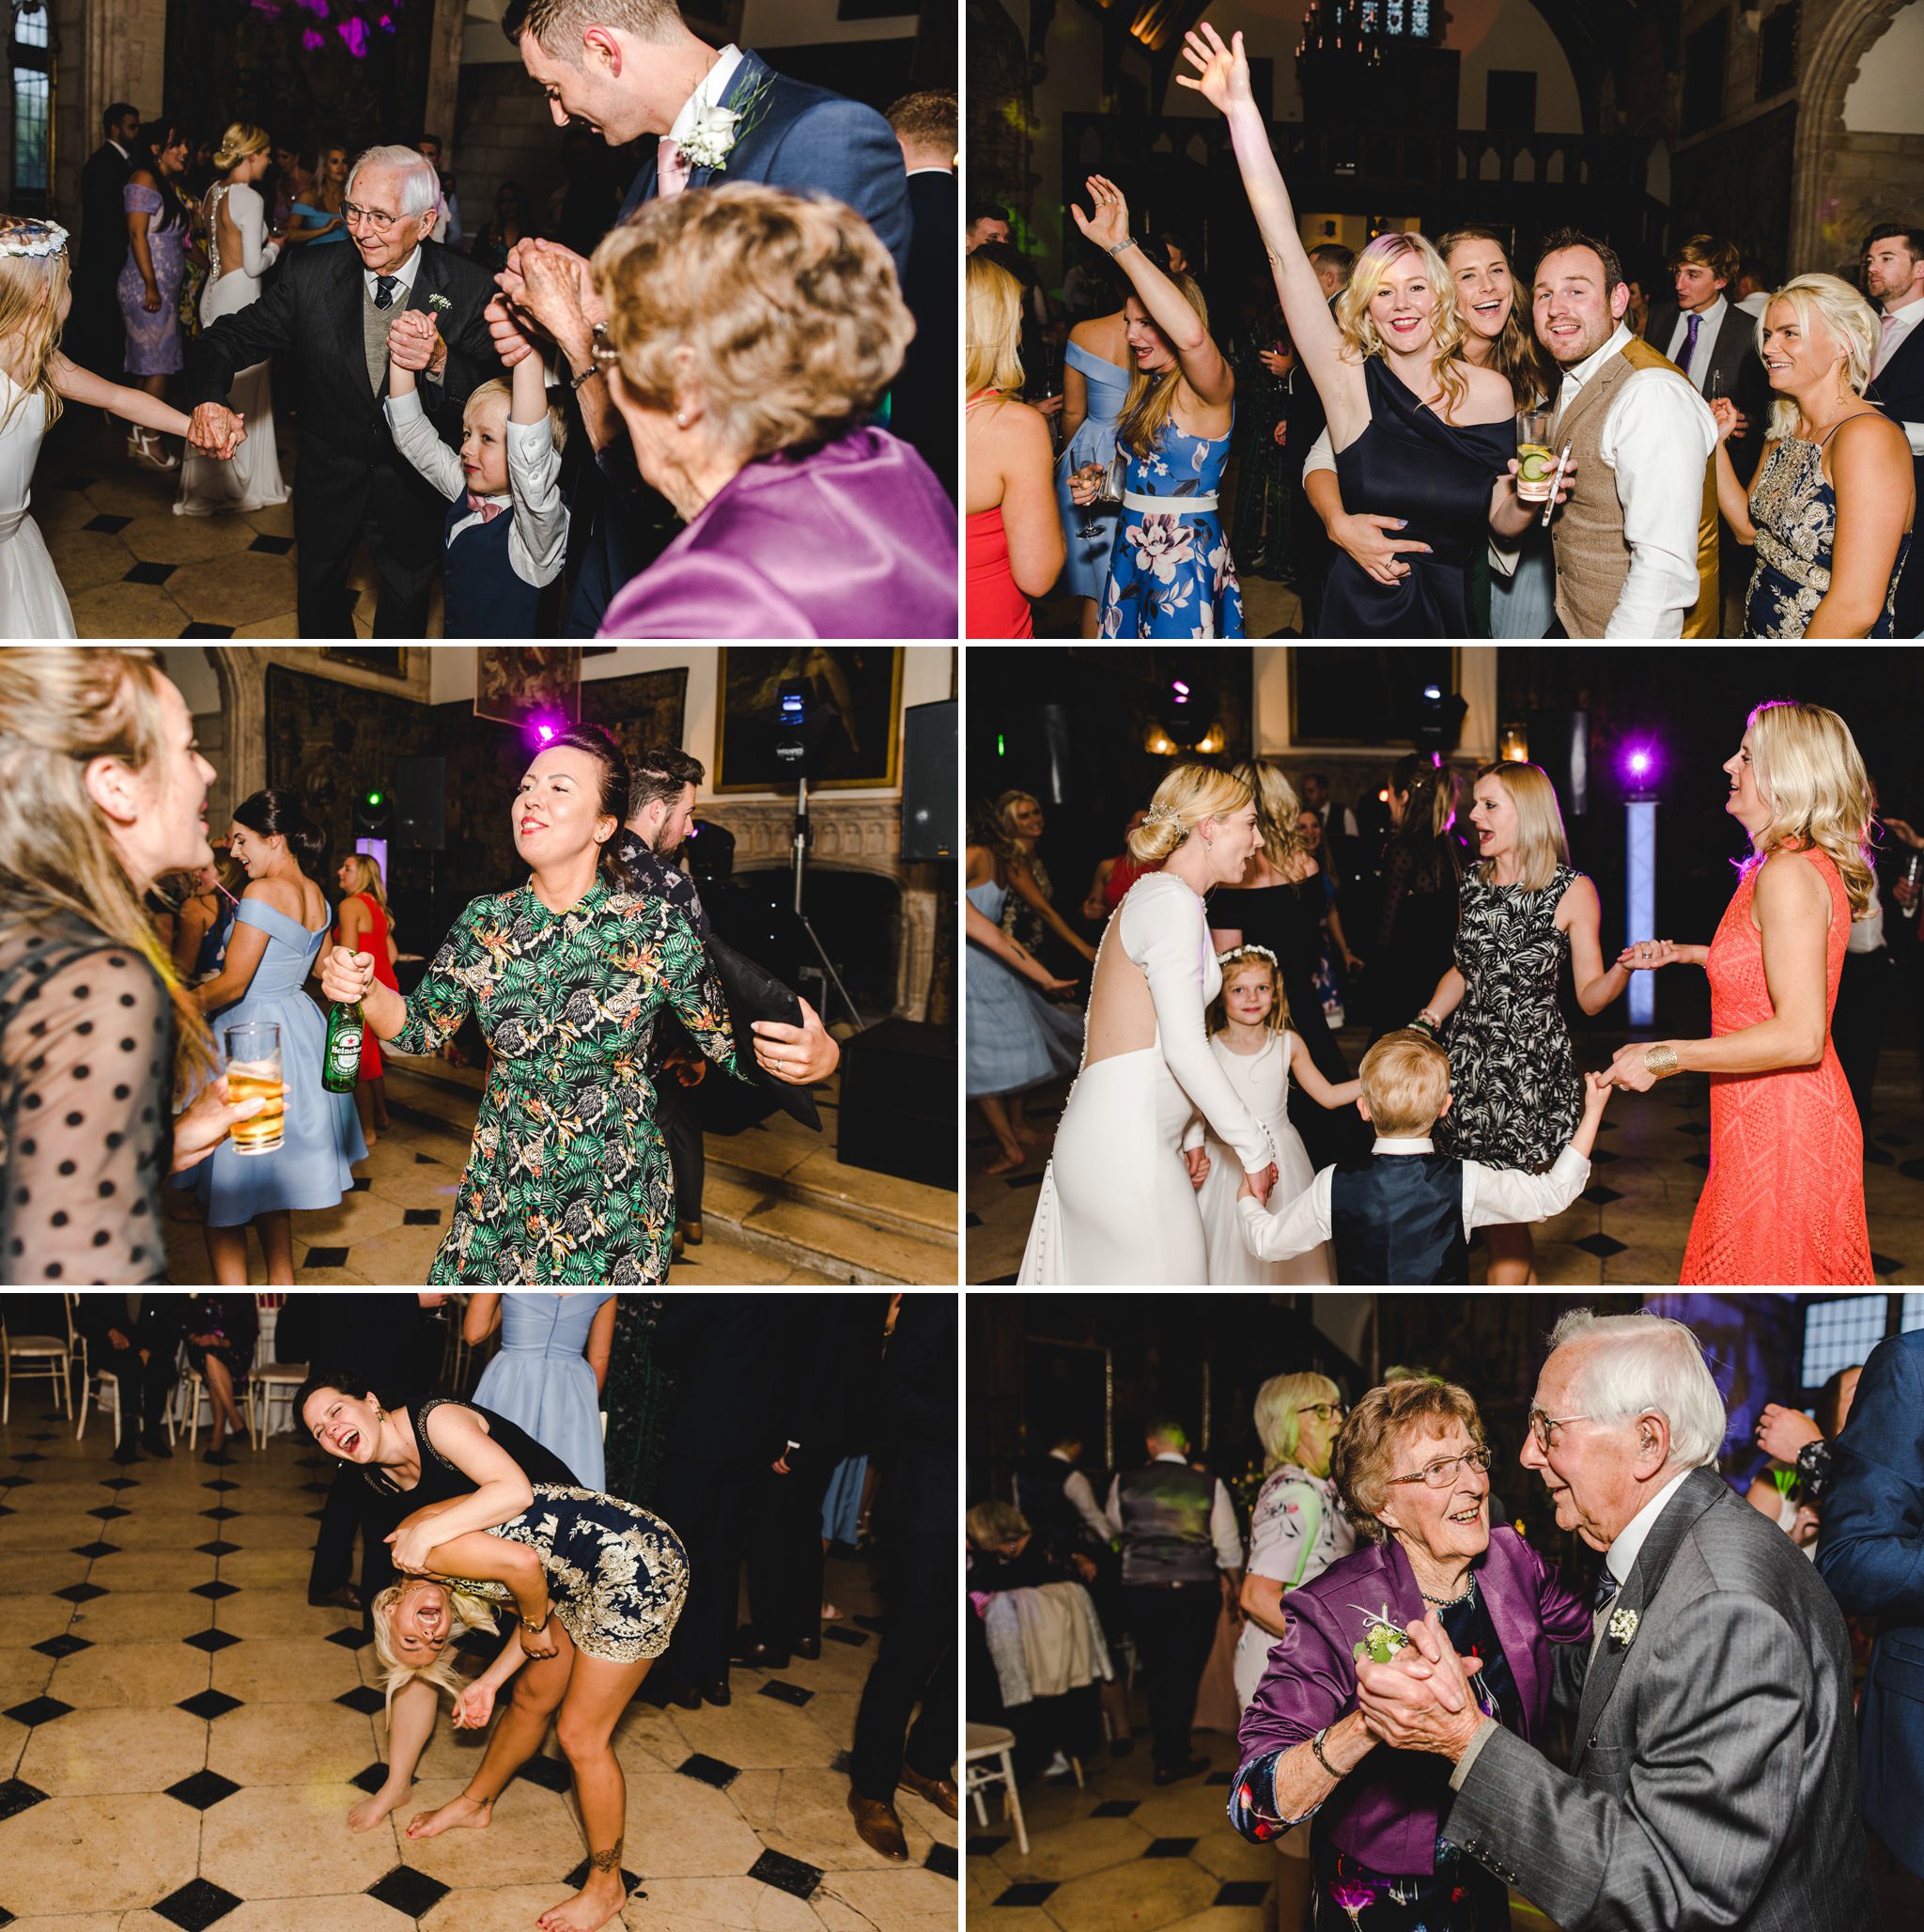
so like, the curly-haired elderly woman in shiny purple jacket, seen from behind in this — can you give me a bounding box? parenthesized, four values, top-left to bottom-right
(593, 181, 956, 640)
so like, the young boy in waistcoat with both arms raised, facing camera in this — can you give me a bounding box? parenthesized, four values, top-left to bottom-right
(386, 309, 568, 637)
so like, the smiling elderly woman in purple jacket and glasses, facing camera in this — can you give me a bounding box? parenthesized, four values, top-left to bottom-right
(1229, 1379, 1591, 1932)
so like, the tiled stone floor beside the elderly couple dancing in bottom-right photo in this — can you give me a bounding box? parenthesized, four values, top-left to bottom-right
(966, 1696, 1555, 1932)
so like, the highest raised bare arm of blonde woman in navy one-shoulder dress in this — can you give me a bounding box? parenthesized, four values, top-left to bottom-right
(1176, 22, 1370, 450)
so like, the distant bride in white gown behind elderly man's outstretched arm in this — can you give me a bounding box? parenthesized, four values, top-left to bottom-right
(174, 122, 287, 516)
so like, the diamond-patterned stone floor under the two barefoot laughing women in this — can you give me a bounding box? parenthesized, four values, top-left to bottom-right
(0, 1391, 956, 1932)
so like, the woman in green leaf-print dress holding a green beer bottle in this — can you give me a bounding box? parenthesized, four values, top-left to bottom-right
(320, 726, 750, 1286)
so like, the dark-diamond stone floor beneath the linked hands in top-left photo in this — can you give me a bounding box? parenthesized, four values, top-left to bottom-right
(33, 410, 441, 637)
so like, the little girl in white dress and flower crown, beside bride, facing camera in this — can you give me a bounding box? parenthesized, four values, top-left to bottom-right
(1182, 946, 1362, 1288)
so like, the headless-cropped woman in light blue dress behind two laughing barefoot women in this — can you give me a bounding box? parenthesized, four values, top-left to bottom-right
(461, 1295, 614, 1489)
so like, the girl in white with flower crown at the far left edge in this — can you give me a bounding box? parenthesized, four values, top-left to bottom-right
(0, 214, 233, 640)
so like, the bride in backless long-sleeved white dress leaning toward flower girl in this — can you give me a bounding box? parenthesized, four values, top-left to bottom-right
(1016, 765, 1275, 1286)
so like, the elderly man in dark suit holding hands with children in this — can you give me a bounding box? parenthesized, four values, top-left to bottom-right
(187, 147, 503, 637)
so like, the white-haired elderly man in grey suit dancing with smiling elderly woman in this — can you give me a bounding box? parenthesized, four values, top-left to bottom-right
(1358, 1310, 1878, 1932)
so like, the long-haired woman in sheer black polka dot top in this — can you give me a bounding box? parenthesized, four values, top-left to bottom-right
(0, 647, 259, 1286)
